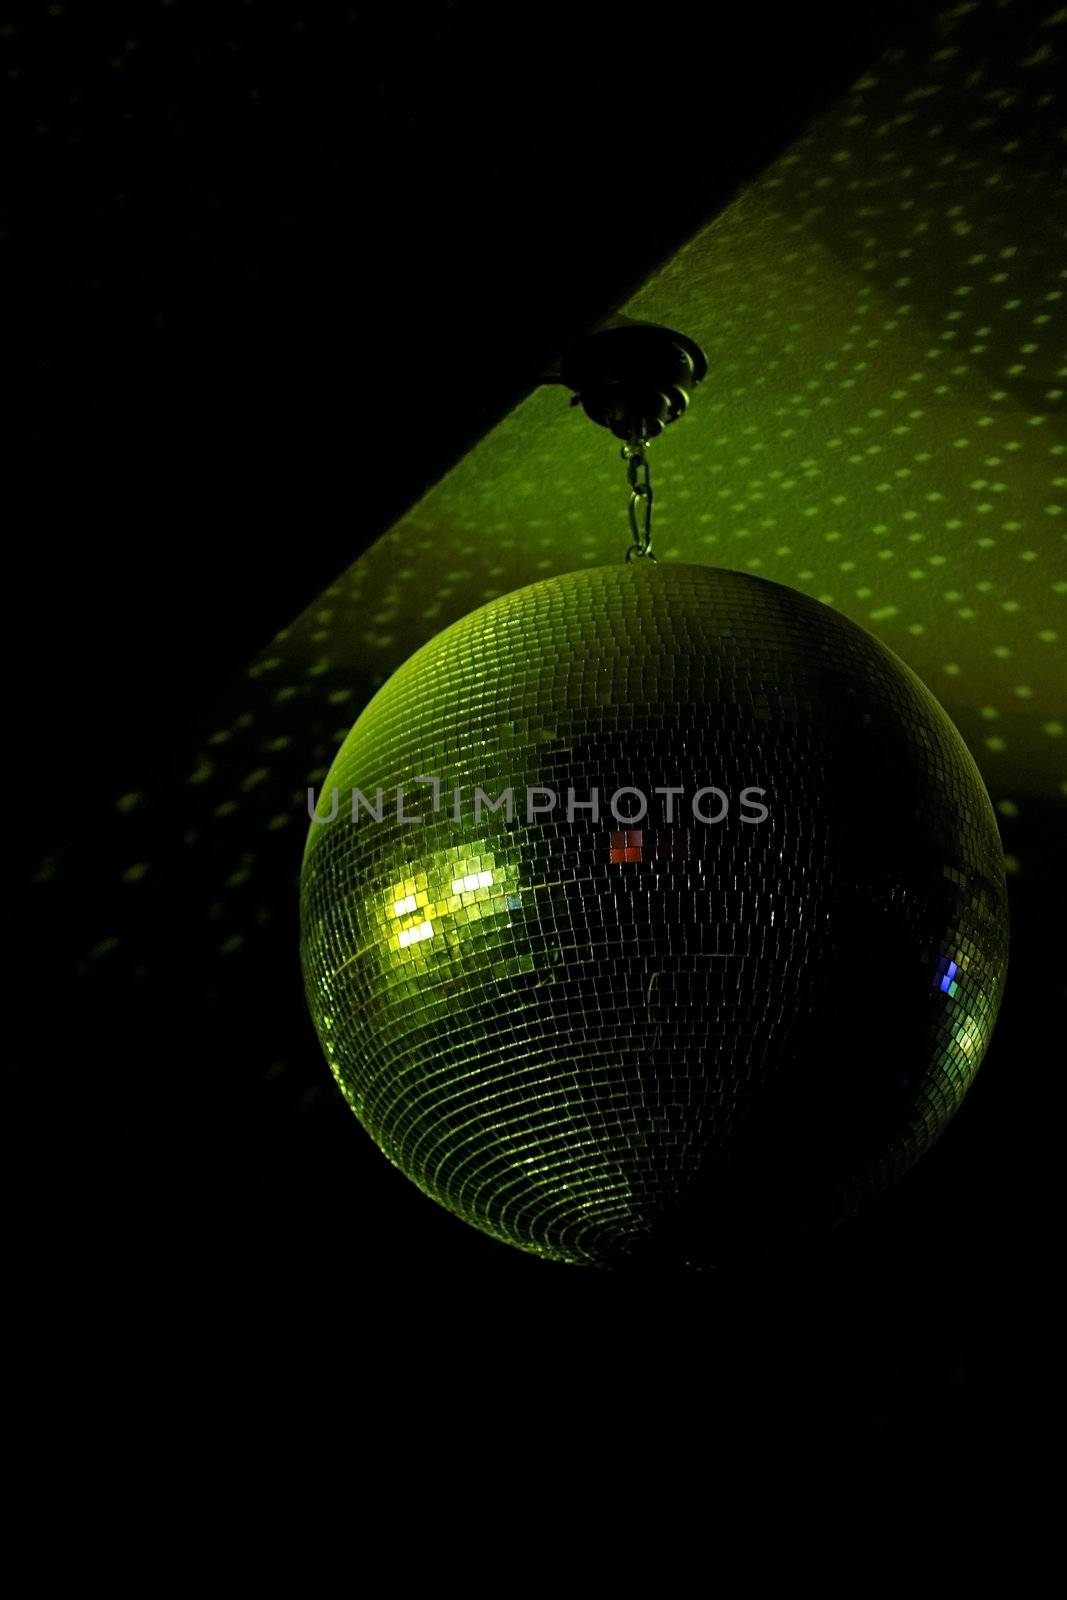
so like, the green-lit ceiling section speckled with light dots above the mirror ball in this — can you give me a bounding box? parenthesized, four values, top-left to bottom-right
(268, 6, 1067, 816)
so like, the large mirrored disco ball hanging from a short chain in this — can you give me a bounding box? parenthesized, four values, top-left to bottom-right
(301, 562, 1008, 1266)
